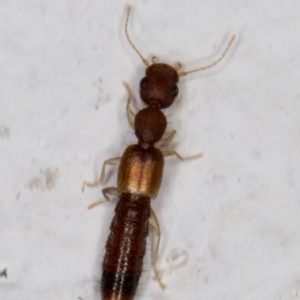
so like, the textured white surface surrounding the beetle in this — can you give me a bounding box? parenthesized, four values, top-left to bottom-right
(0, 0, 300, 300)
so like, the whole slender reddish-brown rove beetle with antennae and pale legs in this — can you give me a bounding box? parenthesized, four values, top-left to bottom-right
(83, 7, 234, 300)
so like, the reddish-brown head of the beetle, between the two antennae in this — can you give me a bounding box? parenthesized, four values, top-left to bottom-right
(140, 64, 179, 108)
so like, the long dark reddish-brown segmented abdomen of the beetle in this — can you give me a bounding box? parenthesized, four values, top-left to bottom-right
(101, 193, 150, 300)
